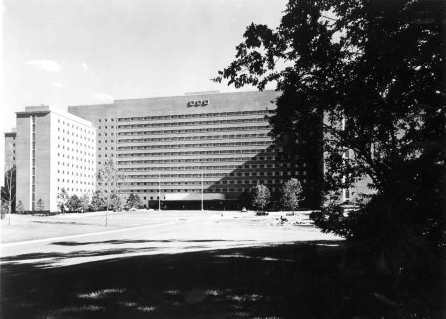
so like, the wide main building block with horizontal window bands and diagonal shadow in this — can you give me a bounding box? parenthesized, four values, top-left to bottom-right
(68, 91, 322, 209)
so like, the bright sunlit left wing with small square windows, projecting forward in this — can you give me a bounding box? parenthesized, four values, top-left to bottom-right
(9, 106, 96, 211)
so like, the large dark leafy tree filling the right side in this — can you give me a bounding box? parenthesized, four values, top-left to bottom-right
(216, 0, 446, 273)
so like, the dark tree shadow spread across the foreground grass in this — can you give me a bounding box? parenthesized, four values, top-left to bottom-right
(0, 241, 444, 319)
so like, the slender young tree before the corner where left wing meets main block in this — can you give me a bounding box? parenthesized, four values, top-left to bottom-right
(96, 159, 126, 225)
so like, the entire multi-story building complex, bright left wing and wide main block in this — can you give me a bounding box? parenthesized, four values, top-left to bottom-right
(2, 91, 369, 211)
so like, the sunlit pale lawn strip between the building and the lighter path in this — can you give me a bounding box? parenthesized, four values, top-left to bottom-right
(1, 210, 316, 244)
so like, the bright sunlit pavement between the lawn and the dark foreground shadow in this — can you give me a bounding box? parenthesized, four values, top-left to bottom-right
(1, 213, 339, 268)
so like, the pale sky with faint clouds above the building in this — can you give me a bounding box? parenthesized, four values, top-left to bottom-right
(0, 0, 286, 183)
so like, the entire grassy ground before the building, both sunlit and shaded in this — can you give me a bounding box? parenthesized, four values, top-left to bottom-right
(0, 212, 444, 319)
